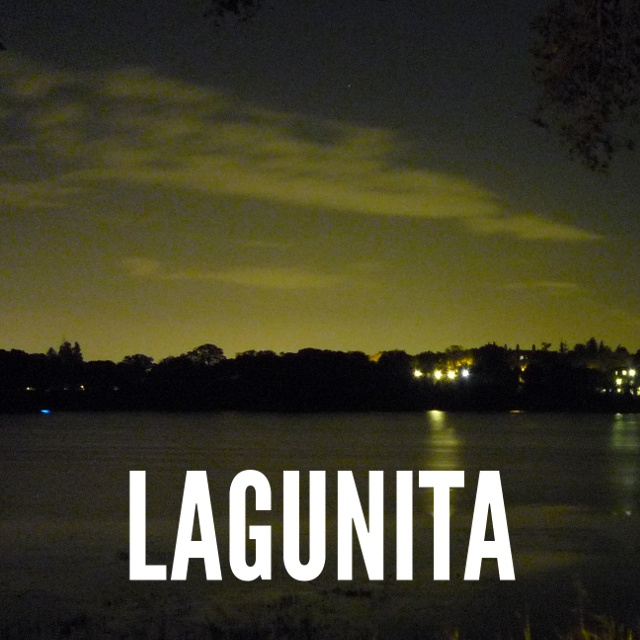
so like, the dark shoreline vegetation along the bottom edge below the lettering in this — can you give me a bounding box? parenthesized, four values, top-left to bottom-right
(0, 587, 640, 640)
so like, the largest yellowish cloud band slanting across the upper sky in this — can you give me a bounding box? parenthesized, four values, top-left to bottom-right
(0, 57, 599, 242)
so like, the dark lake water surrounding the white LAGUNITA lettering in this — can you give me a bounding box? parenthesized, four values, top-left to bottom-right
(0, 411, 640, 638)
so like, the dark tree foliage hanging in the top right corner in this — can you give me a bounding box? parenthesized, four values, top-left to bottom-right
(533, 0, 640, 170)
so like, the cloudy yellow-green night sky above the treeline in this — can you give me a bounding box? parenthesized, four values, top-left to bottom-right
(0, 0, 640, 360)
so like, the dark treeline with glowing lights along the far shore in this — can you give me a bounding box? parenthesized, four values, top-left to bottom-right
(0, 338, 640, 412)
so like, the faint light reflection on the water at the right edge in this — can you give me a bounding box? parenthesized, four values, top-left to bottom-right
(610, 413, 640, 516)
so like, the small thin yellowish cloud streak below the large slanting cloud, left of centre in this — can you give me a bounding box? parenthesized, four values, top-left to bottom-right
(121, 257, 350, 290)
